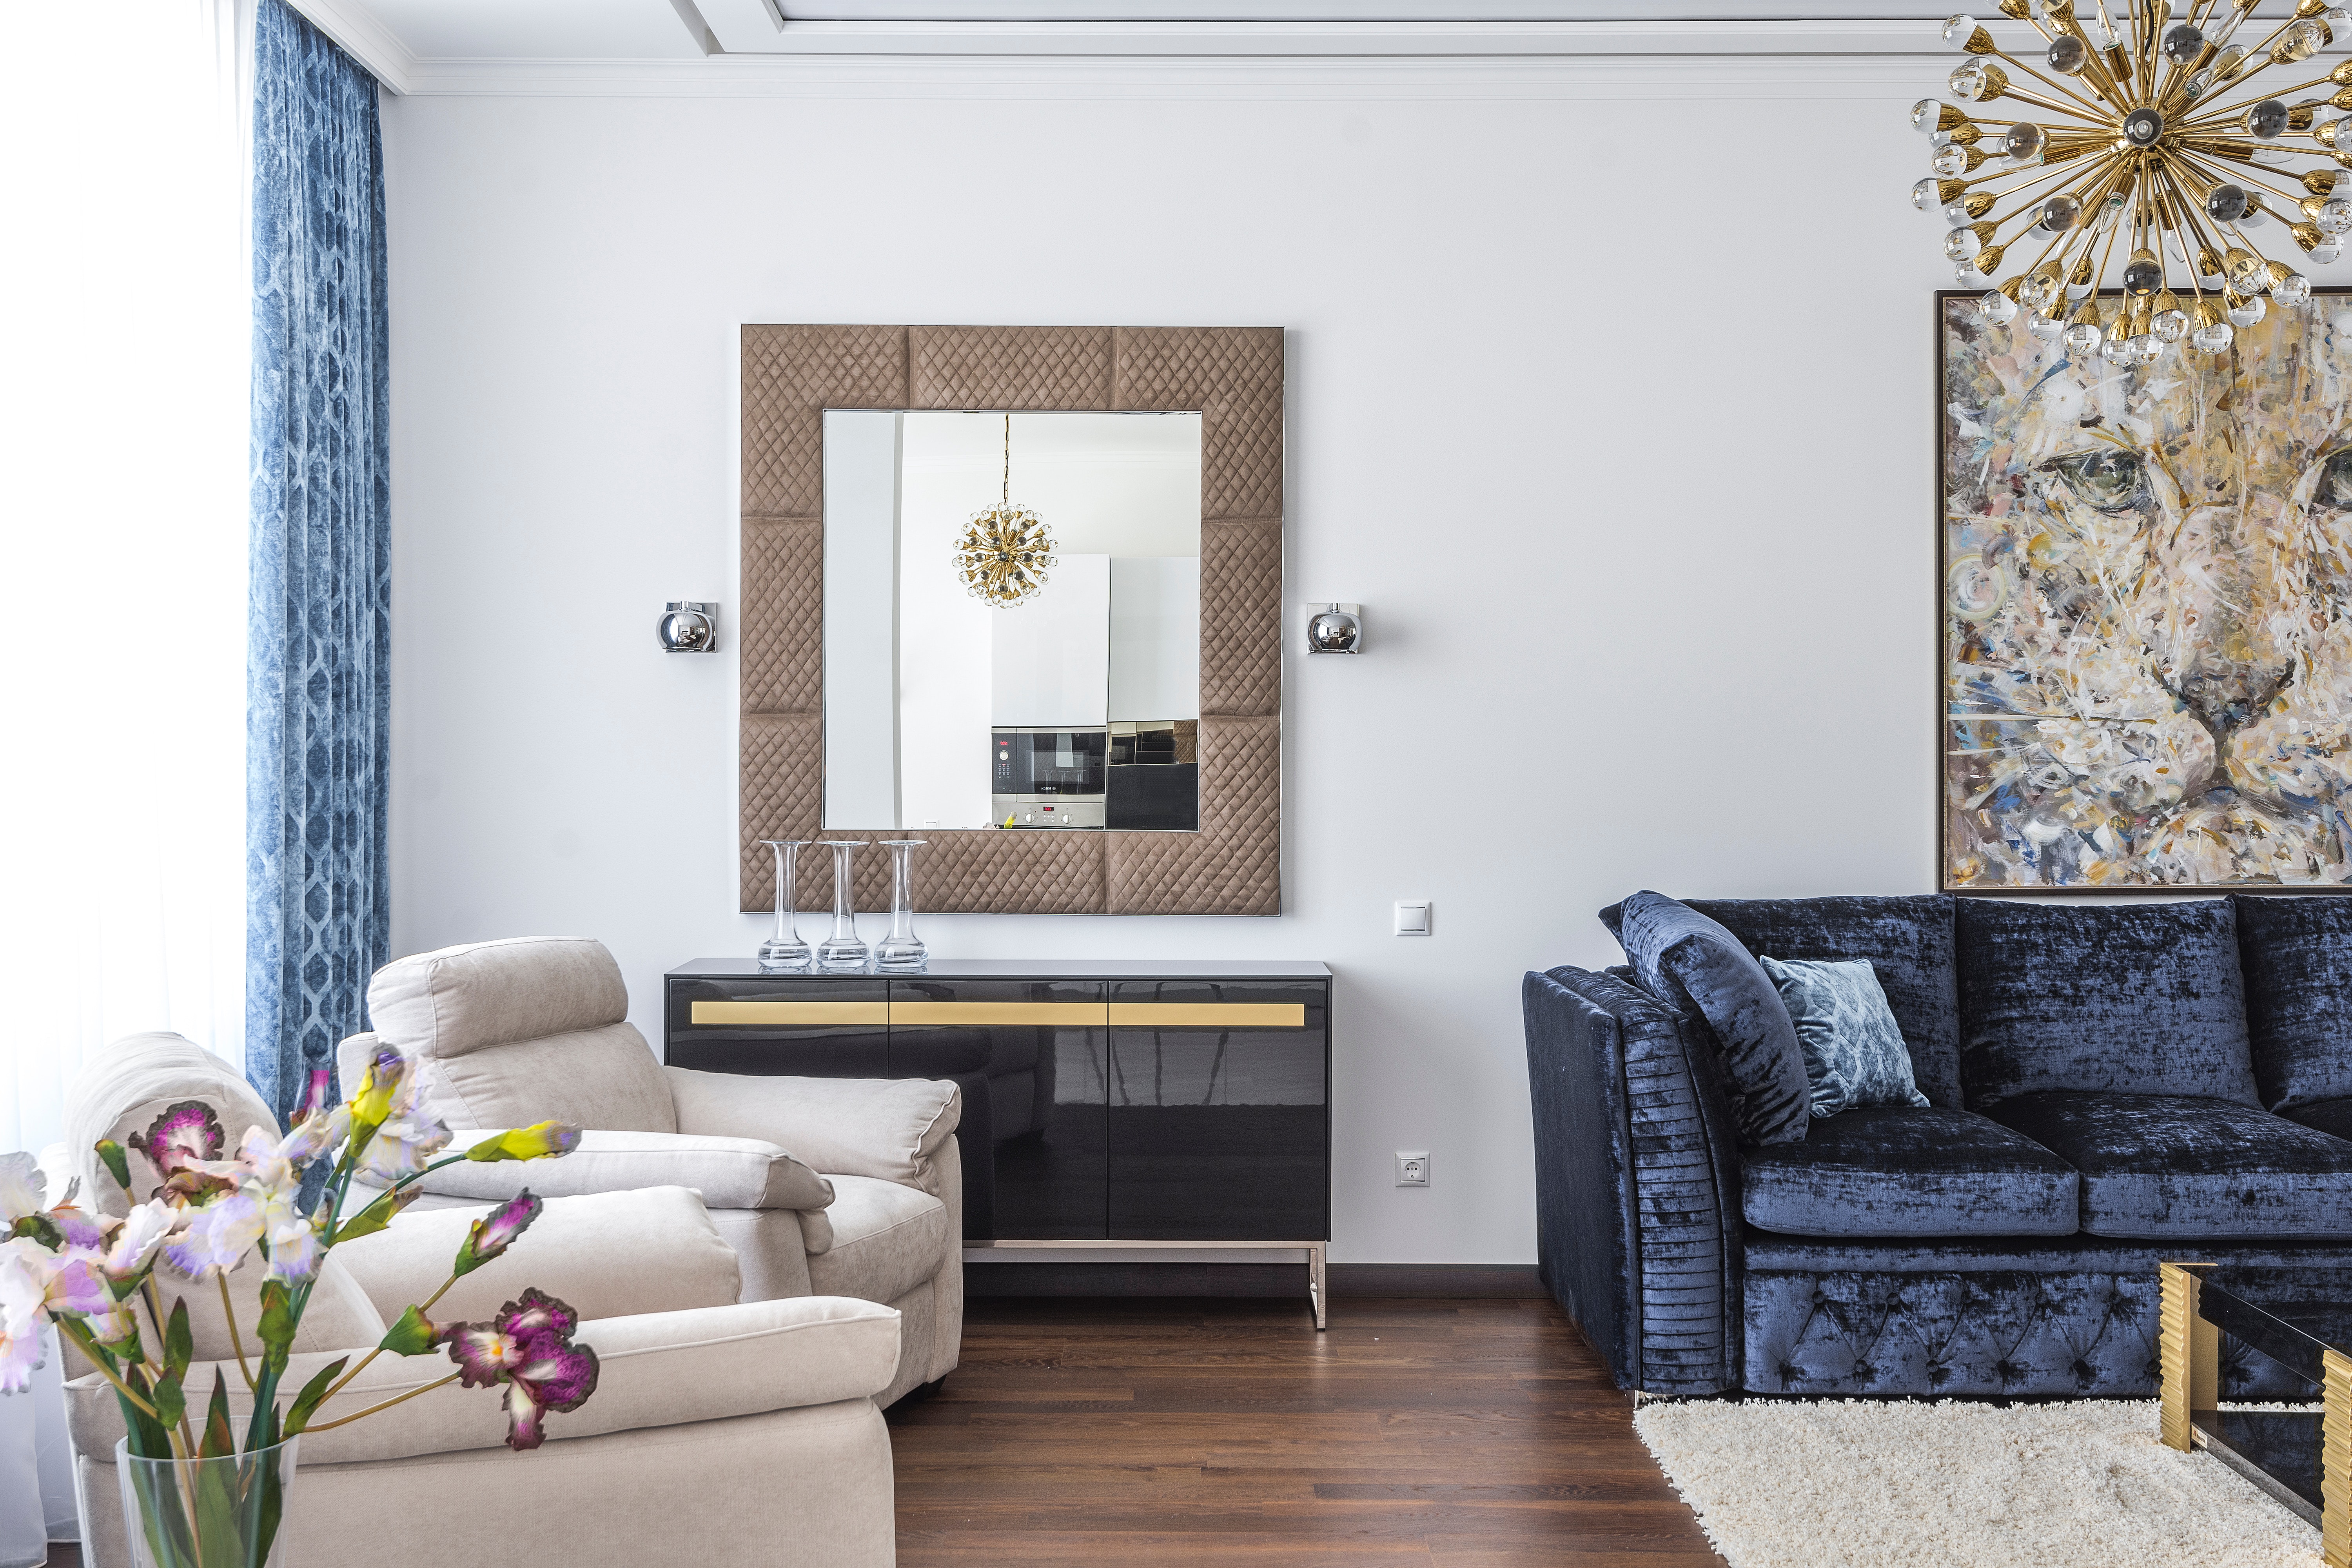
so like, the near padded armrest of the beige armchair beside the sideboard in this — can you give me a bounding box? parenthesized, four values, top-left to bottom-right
(416, 1129, 833, 1208)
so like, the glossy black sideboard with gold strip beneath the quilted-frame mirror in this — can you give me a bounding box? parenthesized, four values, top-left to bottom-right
(663, 959, 1331, 1326)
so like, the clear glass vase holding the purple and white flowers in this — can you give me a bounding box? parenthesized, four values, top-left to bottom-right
(115, 1436, 301, 1568)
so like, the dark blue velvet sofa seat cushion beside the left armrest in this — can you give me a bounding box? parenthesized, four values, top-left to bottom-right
(1740, 1105, 2082, 1236)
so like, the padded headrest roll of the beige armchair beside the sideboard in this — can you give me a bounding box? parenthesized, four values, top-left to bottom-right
(367, 936, 628, 1058)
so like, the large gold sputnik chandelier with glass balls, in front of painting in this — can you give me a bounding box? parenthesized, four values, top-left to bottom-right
(1912, 0, 2352, 365)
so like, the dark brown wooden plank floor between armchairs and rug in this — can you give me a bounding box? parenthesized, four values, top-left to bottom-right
(891, 1298, 1722, 1568)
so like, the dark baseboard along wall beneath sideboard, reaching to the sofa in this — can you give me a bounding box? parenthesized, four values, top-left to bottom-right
(964, 1260, 1543, 1300)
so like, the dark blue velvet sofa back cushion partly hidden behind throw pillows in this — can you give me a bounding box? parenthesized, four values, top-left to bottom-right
(1689, 893, 1962, 1107)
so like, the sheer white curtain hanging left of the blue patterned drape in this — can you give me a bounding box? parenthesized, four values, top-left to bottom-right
(0, 0, 252, 1568)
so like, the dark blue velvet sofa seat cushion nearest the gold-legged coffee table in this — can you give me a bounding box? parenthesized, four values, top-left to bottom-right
(1987, 1089, 2352, 1241)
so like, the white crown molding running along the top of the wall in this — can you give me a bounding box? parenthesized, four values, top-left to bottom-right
(386, 49, 1936, 101)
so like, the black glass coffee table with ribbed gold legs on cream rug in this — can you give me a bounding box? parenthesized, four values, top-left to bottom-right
(2157, 1262, 2352, 1568)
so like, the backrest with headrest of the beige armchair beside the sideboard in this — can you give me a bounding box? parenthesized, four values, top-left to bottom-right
(339, 936, 677, 1133)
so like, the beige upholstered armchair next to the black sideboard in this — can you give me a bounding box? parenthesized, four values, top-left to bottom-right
(339, 936, 964, 1406)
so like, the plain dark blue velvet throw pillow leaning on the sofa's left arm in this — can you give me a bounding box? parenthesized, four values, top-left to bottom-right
(1602, 891, 1811, 1143)
